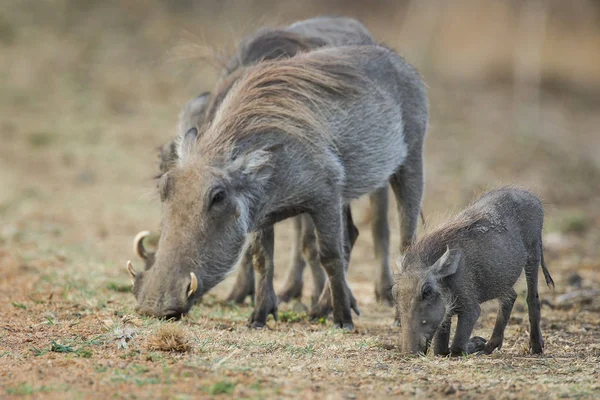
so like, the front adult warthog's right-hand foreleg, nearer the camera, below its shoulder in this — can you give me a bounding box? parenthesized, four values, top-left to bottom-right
(309, 206, 360, 330)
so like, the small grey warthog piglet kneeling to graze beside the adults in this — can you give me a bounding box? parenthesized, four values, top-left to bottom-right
(393, 186, 554, 356)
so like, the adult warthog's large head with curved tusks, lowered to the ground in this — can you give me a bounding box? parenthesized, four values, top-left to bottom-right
(128, 128, 272, 318)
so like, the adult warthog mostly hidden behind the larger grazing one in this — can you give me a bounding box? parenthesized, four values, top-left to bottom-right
(136, 17, 408, 313)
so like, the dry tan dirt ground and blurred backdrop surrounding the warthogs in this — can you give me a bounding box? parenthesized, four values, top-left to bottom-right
(0, 0, 600, 399)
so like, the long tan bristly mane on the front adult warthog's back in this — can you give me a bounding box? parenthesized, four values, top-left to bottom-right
(196, 53, 364, 156)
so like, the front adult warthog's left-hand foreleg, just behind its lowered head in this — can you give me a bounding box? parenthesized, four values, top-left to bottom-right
(248, 226, 277, 328)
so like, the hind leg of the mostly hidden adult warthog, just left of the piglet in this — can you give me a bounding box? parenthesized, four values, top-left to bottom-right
(369, 186, 394, 306)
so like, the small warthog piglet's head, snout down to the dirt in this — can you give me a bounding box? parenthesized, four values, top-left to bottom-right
(392, 249, 462, 354)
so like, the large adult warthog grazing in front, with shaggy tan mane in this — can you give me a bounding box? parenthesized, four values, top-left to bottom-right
(133, 45, 428, 329)
